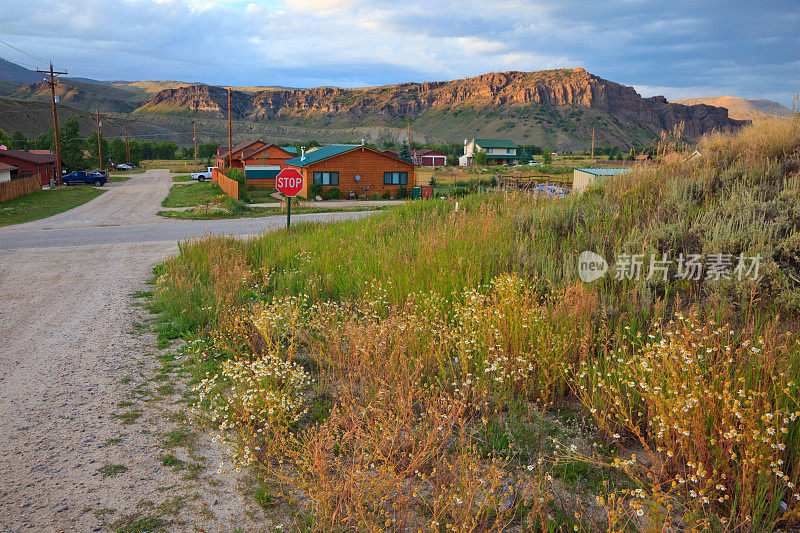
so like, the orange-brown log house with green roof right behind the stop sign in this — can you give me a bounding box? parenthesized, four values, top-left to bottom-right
(285, 144, 416, 198)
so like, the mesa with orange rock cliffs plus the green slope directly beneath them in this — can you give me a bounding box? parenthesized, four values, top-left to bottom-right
(136, 68, 743, 148)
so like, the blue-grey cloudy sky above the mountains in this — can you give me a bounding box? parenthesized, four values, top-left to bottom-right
(0, 0, 800, 106)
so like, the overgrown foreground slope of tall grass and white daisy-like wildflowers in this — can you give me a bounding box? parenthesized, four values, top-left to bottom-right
(153, 118, 800, 531)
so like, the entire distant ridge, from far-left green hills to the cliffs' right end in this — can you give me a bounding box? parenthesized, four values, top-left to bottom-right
(0, 57, 744, 149)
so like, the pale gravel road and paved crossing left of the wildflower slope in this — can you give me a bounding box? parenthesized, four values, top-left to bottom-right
(0, 171, 363, 531)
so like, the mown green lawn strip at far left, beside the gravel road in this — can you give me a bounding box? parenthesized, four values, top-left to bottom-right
(0, 186, 105, 226)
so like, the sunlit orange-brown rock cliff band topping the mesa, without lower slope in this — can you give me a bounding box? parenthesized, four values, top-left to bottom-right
(137, 68, 743, 143)
